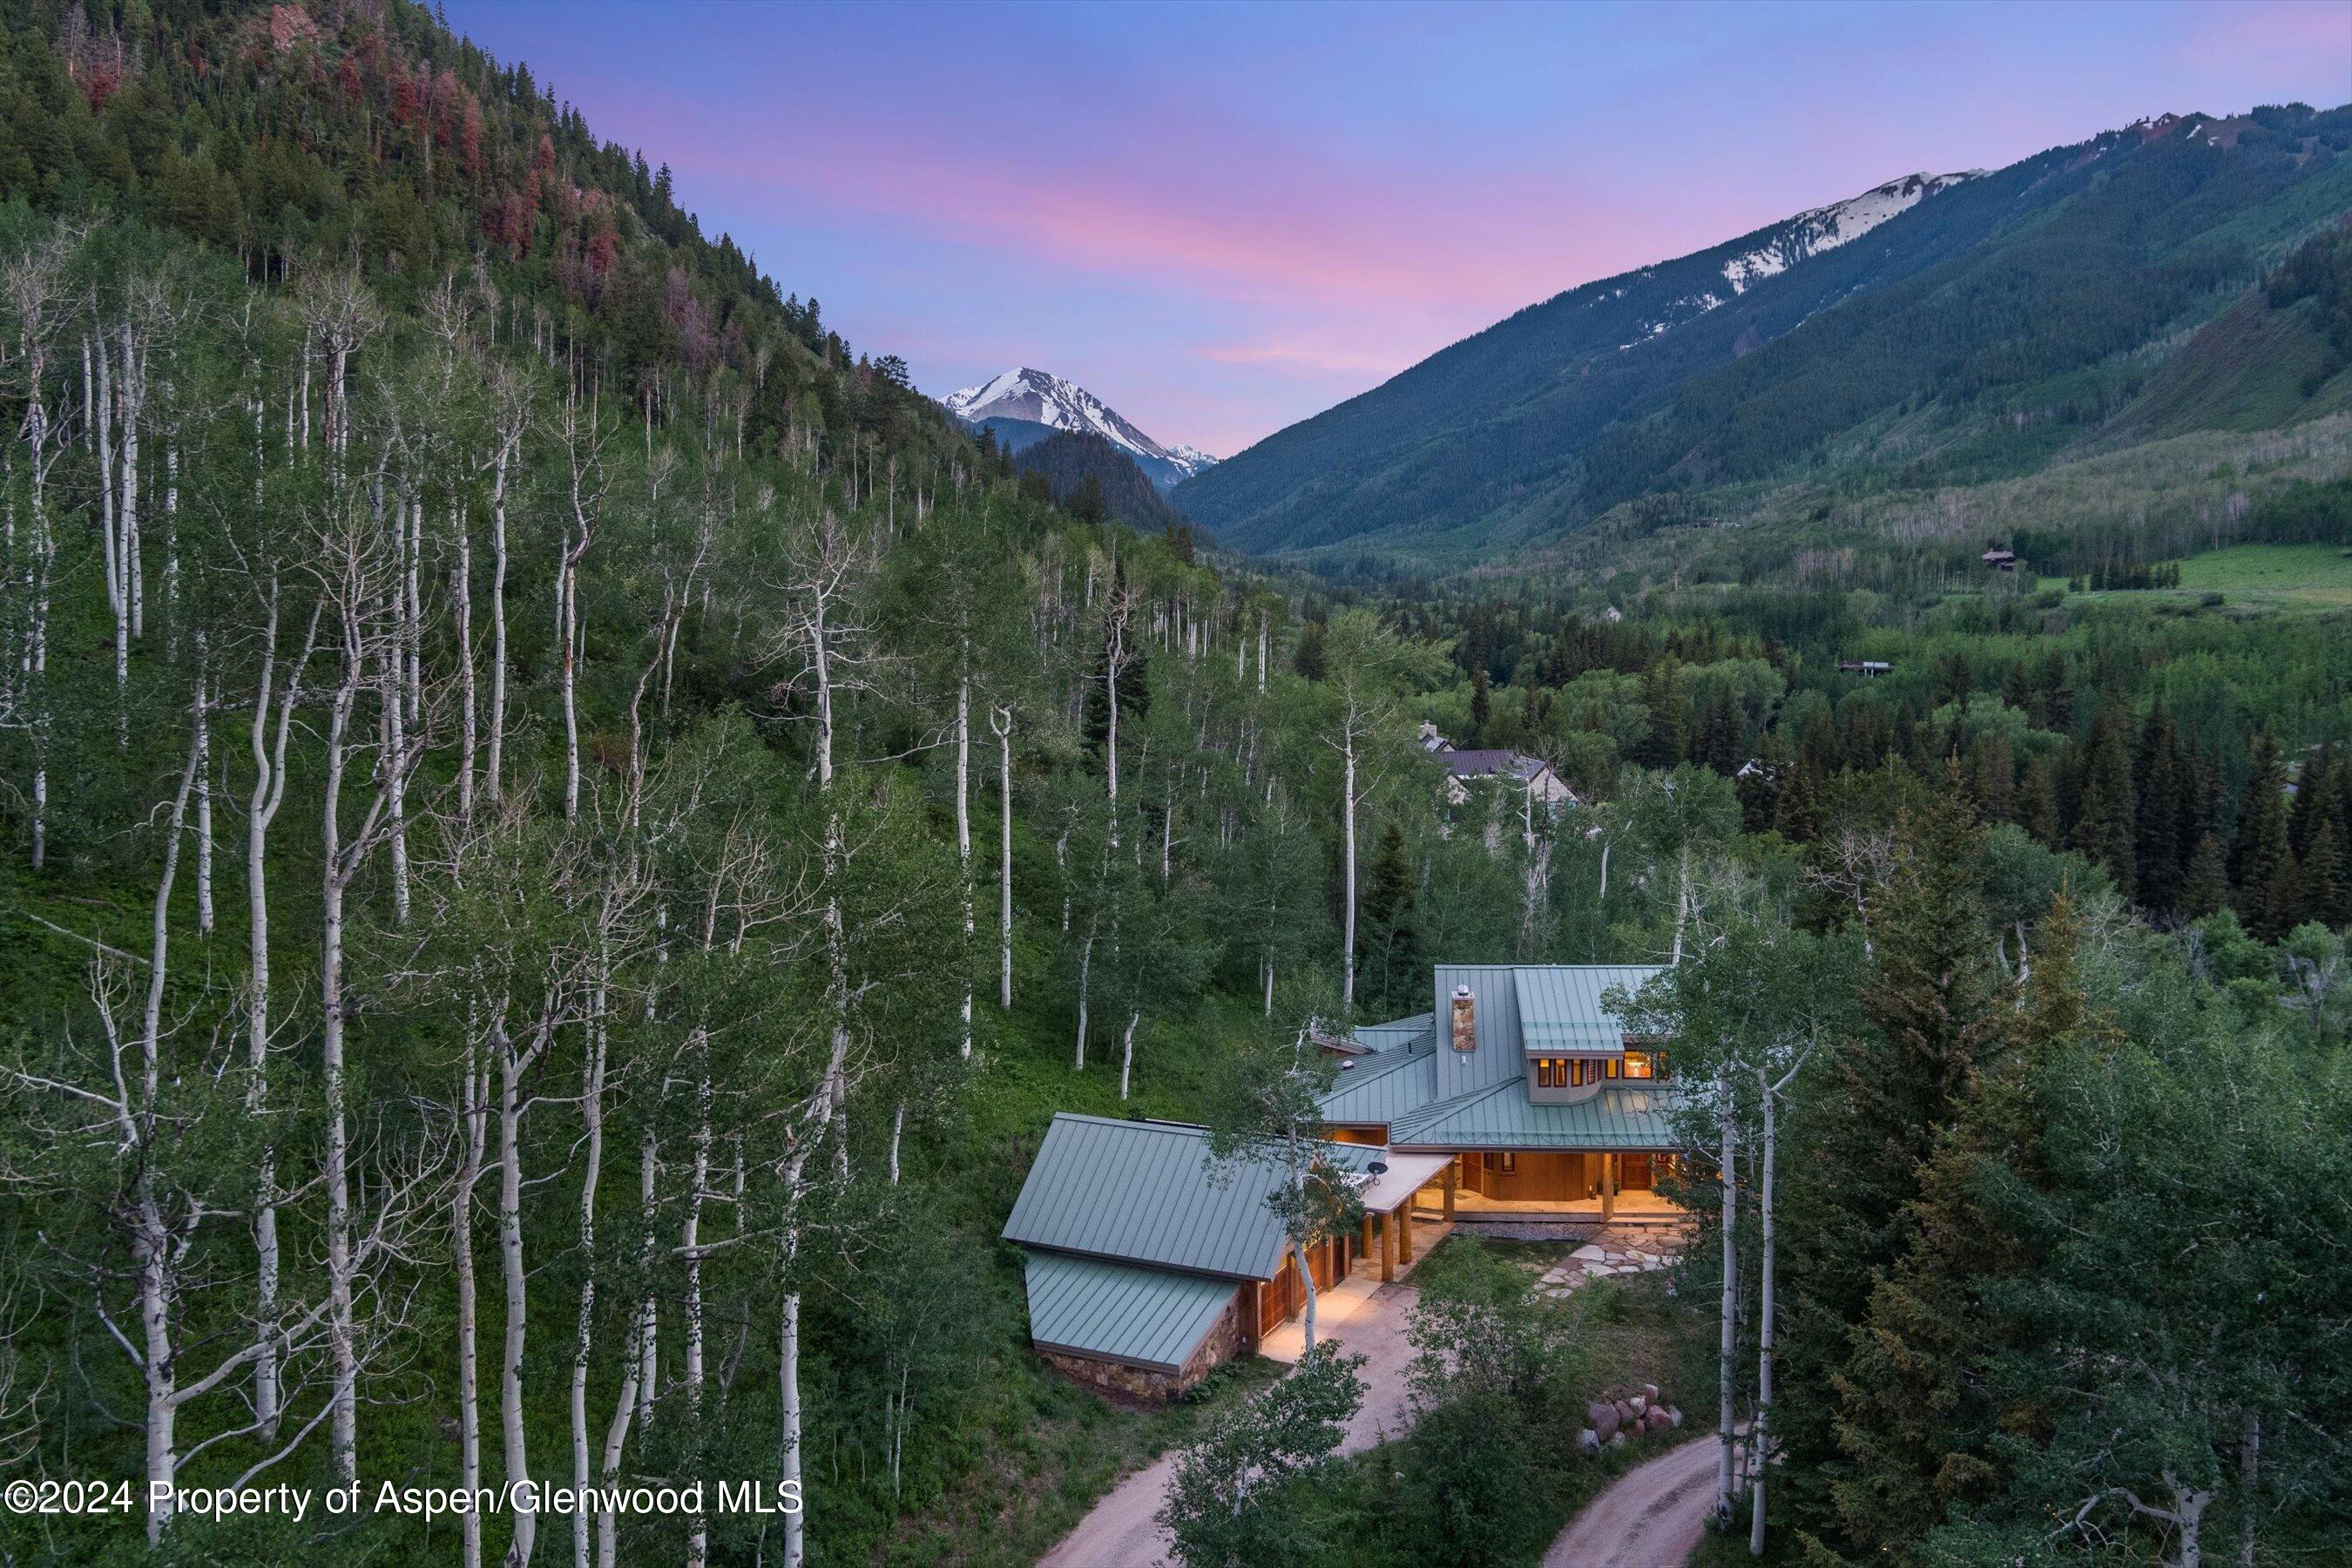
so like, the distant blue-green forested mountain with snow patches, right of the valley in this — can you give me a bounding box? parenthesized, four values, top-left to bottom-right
(1179, 105, 2352, 558)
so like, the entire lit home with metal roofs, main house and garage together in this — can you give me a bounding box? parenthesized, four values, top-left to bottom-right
(1004, 963, 1684, 1399)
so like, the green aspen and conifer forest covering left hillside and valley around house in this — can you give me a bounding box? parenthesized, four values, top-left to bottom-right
(0, 0, 2352, 1565)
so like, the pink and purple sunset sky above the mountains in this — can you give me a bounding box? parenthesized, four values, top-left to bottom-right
(451, 0, 2352, 456)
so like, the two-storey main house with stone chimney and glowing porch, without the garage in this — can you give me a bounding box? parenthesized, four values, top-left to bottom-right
(1321, 963, 1682, 1222)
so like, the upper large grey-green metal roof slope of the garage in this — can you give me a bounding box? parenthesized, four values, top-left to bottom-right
(1004, 1112, 1381, 1279)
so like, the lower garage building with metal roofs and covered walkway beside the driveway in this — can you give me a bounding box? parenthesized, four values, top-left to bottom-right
(1004, 1112, 1449, 1399)
